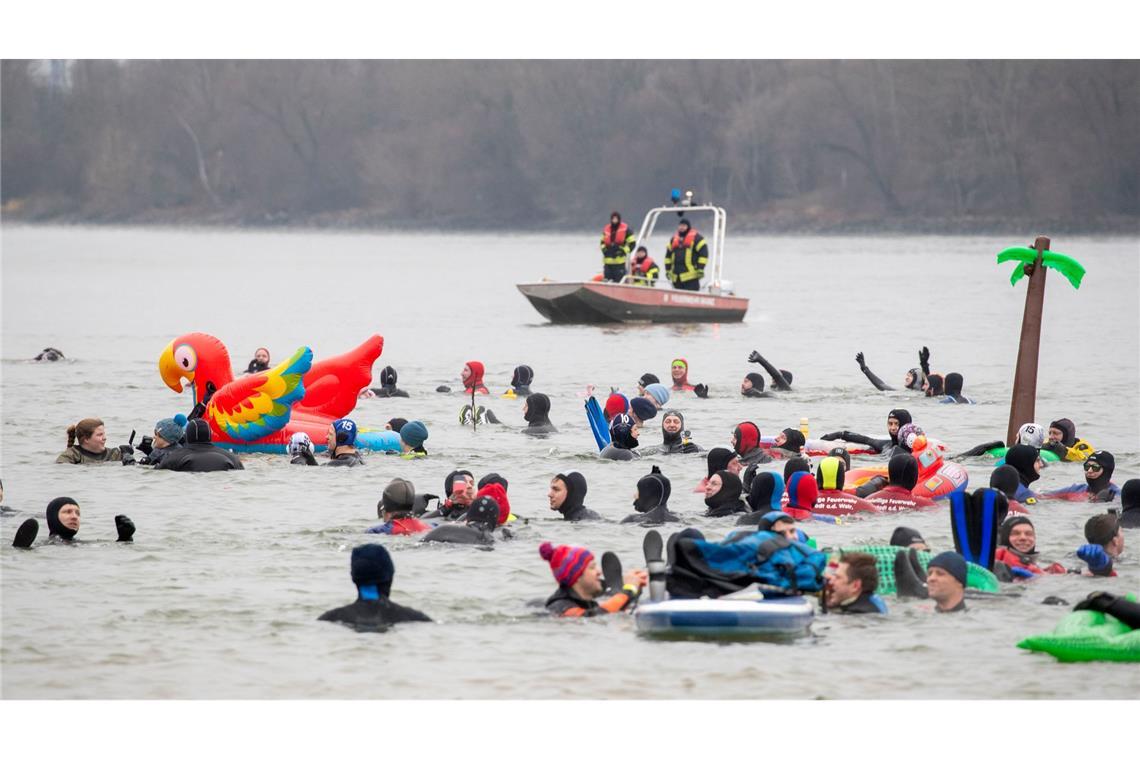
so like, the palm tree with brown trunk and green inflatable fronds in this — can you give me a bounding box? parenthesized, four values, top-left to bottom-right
(998, 237, 1084, 446)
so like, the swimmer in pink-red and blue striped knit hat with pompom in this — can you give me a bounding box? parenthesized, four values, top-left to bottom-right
(538, 541, 649, 618)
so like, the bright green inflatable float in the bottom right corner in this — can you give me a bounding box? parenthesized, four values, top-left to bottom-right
(1017, 595, 1140, 662)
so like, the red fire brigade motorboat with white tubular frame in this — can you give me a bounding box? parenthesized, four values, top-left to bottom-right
(516, 198, 748, 325)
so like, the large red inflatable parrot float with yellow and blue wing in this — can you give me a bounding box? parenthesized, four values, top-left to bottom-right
(158, 333, 400, 453)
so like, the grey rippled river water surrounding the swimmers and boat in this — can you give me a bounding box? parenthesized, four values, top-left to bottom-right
(0, 227, 1140, 698)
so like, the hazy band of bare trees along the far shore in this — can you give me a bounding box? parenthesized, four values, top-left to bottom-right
(0, 60, 1140, 230)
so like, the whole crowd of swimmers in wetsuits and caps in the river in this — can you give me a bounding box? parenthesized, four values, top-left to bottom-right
(13, 346, 1140, 630)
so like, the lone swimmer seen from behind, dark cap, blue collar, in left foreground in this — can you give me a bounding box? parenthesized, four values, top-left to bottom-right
(317, 544, 431, 634)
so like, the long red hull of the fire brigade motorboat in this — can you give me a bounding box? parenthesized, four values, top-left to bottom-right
(518, 281, 748, 325)
